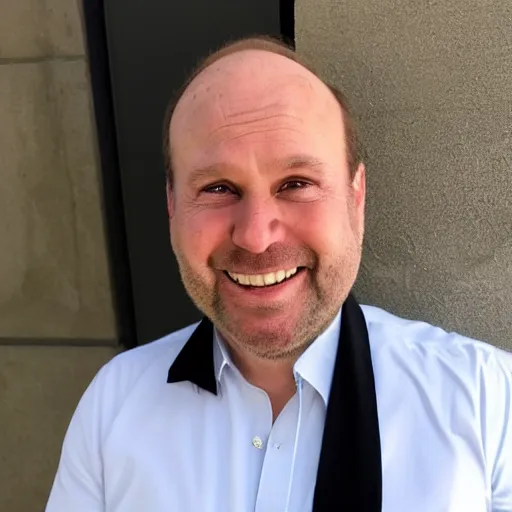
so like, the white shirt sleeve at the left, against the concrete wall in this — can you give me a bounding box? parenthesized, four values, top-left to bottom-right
(46, 375, 105, 512)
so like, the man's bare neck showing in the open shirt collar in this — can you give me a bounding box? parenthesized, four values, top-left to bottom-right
(229, 345, 297, 421)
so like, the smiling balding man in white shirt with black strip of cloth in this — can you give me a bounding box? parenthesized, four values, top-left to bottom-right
(47, 39, 512, 512)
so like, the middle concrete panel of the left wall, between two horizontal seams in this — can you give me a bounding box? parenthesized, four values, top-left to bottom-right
(0, 61, 117, 341)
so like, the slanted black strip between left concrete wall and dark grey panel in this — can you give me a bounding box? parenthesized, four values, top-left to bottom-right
(82, 0, 137, 348)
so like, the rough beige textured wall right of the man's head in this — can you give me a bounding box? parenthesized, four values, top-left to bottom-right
(296, 0, 512, 349)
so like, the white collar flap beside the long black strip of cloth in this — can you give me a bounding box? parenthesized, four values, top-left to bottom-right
(294, 311, 341, 406)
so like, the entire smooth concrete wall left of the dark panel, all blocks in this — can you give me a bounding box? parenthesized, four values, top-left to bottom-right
(0, 0, 118, 512)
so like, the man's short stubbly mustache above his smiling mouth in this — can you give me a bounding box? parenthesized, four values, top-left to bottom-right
(209, 243, 317, 274)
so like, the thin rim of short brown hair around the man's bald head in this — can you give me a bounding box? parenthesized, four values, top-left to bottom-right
(163, 36, 362, 184)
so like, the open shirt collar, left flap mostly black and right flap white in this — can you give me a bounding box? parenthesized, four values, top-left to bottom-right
(167, 311, 341, 405)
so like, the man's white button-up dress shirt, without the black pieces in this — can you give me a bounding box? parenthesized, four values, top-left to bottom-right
(46, 306, 512, 512)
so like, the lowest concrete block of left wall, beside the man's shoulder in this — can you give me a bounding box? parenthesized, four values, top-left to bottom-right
(0, 346, 115, 512)
